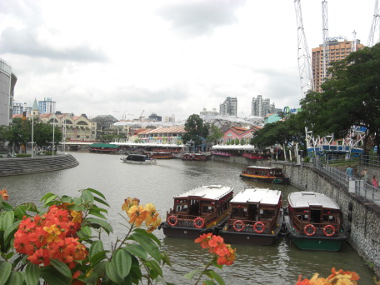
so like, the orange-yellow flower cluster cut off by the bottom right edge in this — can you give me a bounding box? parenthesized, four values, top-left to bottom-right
(296, 268, 359, 285)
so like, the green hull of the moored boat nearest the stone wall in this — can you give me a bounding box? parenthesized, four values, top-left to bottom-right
(284, 215, 347, 251)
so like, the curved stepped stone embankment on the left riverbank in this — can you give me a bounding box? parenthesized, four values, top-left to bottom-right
(0, 154, 79, 177)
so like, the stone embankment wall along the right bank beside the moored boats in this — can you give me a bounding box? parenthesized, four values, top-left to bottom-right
(272, 163, 380, 277)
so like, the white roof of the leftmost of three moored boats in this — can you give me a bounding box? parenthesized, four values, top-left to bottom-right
(174, 185, 233, 200)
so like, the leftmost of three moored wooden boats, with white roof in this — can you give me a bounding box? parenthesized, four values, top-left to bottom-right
(160, 185, 233, 239)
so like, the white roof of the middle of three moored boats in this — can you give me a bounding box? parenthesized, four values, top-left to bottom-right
(230, 188, 281, 205)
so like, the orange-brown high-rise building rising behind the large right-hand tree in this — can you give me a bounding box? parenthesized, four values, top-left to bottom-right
(312, 39, 364, 92)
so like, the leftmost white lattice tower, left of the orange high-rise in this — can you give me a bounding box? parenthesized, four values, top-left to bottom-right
(294, 0, 314, 95)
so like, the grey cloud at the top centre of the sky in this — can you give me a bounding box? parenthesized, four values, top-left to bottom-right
(158, 0, 246, 36)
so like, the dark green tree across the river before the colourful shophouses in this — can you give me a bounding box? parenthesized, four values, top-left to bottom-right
(182, 114, 209, 146)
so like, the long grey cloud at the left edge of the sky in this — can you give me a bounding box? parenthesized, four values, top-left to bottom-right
(0, 28, 107, 62)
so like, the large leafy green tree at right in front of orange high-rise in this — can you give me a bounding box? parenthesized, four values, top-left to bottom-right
(301, 44, 380, 156)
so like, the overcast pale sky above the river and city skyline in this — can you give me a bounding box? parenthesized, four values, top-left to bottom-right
(0, 0, 375, 119)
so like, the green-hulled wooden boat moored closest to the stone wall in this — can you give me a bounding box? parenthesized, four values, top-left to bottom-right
(284, 192, 347, 251)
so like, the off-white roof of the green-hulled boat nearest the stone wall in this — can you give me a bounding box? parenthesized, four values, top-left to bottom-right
(288, 192, 340, 210)
